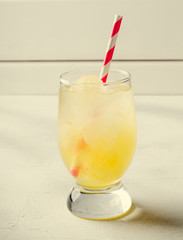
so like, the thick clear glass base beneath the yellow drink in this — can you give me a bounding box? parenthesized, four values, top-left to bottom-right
(67, 182, 132, 220)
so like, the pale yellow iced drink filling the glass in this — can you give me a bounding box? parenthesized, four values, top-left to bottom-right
(58, 76, 136, 189)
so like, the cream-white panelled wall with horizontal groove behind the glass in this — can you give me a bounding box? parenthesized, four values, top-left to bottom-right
(0, 0, 183, 94)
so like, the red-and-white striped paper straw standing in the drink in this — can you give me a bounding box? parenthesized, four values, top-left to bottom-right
(100, 15, 123, 83)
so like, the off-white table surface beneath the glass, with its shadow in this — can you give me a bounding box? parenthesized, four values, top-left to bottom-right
(0, 96, 183, 240)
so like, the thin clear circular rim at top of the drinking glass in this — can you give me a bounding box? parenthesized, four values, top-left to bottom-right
(60, 68, 131, 86)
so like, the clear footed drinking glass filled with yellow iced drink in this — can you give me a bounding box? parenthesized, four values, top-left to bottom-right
(58, 69, 136, 220)
